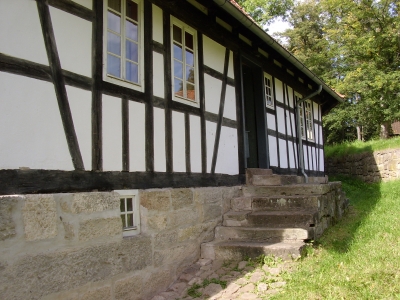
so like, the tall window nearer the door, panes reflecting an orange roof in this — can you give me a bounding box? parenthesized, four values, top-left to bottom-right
(171, 18, 199, 107)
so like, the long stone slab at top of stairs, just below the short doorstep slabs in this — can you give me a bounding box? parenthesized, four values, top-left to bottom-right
(243, 184, 330, 197)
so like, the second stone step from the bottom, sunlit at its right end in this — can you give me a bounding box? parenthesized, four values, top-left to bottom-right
(215, 226, 314, 243)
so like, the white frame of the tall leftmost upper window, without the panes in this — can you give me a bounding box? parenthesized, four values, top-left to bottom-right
(103, 0, 144, 92)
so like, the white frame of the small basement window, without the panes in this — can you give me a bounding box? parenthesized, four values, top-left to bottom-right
(114, 190, 140, 237)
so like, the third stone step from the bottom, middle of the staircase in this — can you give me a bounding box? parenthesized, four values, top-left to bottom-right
(223, 209, 318, 229)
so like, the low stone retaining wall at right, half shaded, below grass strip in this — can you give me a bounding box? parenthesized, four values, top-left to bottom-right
(325, 149, 400, 182)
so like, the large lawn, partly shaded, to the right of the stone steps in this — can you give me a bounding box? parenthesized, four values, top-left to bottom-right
(273, 177, 400, 300)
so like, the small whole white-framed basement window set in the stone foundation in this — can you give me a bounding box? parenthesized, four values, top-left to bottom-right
(115, 190, 140, 236)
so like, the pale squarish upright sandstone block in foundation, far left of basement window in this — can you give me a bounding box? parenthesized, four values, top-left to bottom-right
(22, 195, 57, 241)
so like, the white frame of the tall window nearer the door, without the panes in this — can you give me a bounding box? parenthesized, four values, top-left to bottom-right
(170, 16, 200, 107)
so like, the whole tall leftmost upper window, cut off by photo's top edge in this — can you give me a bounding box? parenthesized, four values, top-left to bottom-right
(103, 0, 143, 91)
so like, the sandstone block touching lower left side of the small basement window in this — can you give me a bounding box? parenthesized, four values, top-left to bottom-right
(79, 216, 122, 241)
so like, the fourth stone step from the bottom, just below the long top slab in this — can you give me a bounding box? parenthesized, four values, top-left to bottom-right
(231, 195, 321, 211)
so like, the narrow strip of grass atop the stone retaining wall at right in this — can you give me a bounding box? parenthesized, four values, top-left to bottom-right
(324, 137, 400, 158)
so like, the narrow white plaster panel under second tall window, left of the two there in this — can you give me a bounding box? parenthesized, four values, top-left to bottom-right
(172, 111, 186, 172)
